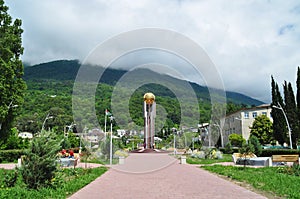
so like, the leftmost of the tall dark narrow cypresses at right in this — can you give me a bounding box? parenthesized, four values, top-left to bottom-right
(271, 76, 287, 145)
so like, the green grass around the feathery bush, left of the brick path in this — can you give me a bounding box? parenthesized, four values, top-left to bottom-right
(0, 167, 107, 199)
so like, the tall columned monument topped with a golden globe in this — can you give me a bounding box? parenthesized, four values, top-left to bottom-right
(144, 93, 156, 149)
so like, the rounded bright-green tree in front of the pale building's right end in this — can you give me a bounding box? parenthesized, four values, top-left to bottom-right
(250, 115, 273, 145)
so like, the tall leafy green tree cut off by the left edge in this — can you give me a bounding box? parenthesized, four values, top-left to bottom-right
(0, 0, 26, 141)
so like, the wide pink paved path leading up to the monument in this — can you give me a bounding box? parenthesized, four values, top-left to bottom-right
(69, 153, 265, 199)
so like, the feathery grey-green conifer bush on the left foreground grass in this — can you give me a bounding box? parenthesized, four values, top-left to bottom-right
(20, 131, 60, 189)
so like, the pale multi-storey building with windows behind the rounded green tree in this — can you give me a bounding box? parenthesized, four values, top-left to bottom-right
(222, 104, 273, 145)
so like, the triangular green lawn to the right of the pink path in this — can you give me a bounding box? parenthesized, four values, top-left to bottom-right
(201, 165, 300, 198)
